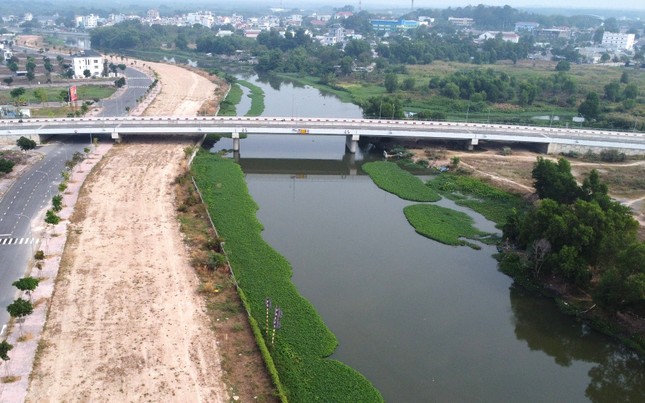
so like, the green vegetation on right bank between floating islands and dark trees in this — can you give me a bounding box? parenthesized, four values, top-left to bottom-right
(427, 173, 526, 228)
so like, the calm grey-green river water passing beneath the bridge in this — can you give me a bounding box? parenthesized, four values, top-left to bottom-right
(216, 77, 645, 402)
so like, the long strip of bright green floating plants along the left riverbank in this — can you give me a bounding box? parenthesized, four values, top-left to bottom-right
(192, 152, 383, 402)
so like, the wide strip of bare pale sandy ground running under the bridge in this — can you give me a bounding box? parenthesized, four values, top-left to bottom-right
(27, 64, 228, 402)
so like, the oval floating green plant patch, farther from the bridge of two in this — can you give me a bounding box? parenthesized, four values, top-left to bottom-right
(403, 204, 489, 249)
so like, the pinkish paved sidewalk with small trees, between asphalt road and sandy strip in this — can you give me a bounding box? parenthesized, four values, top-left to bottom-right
(0, 144, 112, 402)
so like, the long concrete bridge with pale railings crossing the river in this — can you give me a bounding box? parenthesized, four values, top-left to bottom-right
(0, 116, 645, 154)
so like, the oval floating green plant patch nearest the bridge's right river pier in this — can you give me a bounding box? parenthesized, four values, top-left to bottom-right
(362, 161, 441, 202)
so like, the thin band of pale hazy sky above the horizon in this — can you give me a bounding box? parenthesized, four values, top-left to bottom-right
(271, 0, 645, 10)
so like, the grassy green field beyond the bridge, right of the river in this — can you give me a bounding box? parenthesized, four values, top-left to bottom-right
(279, 60, 645, 128)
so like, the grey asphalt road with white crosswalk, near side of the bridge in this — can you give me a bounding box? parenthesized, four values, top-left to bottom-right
(0, 138, 89, 327)
